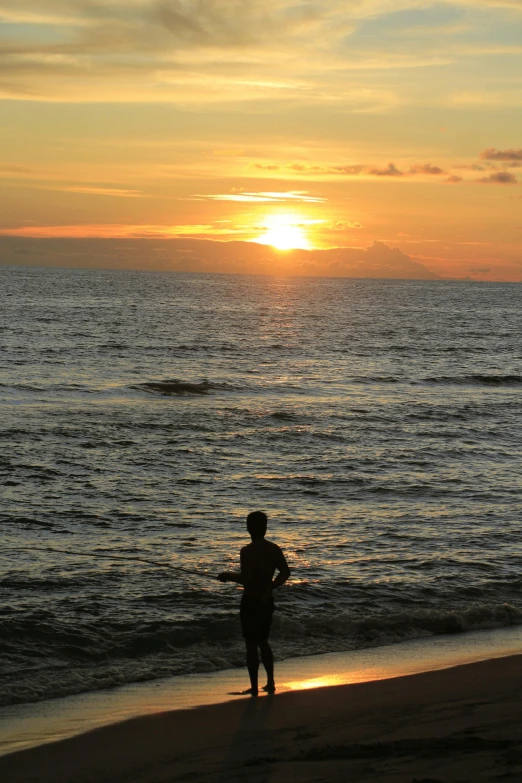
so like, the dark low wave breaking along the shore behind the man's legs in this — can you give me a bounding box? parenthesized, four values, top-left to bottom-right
(0, 603, 522, 706)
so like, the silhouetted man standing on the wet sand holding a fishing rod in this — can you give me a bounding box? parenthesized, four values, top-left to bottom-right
(218, 511, 290, 696)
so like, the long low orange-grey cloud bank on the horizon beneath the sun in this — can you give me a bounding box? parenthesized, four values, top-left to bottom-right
(0, 235, 437, 280)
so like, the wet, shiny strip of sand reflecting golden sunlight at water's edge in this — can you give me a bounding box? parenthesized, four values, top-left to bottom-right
(0, 626, 522, 757)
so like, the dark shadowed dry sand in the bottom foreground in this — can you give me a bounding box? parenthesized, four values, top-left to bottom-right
(0, 655, 522, 783)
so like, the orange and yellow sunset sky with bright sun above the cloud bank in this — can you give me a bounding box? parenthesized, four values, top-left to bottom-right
(0, 0, 522, 281)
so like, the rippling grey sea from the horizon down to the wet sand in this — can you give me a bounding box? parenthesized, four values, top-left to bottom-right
(0, 267, 522, 705)
